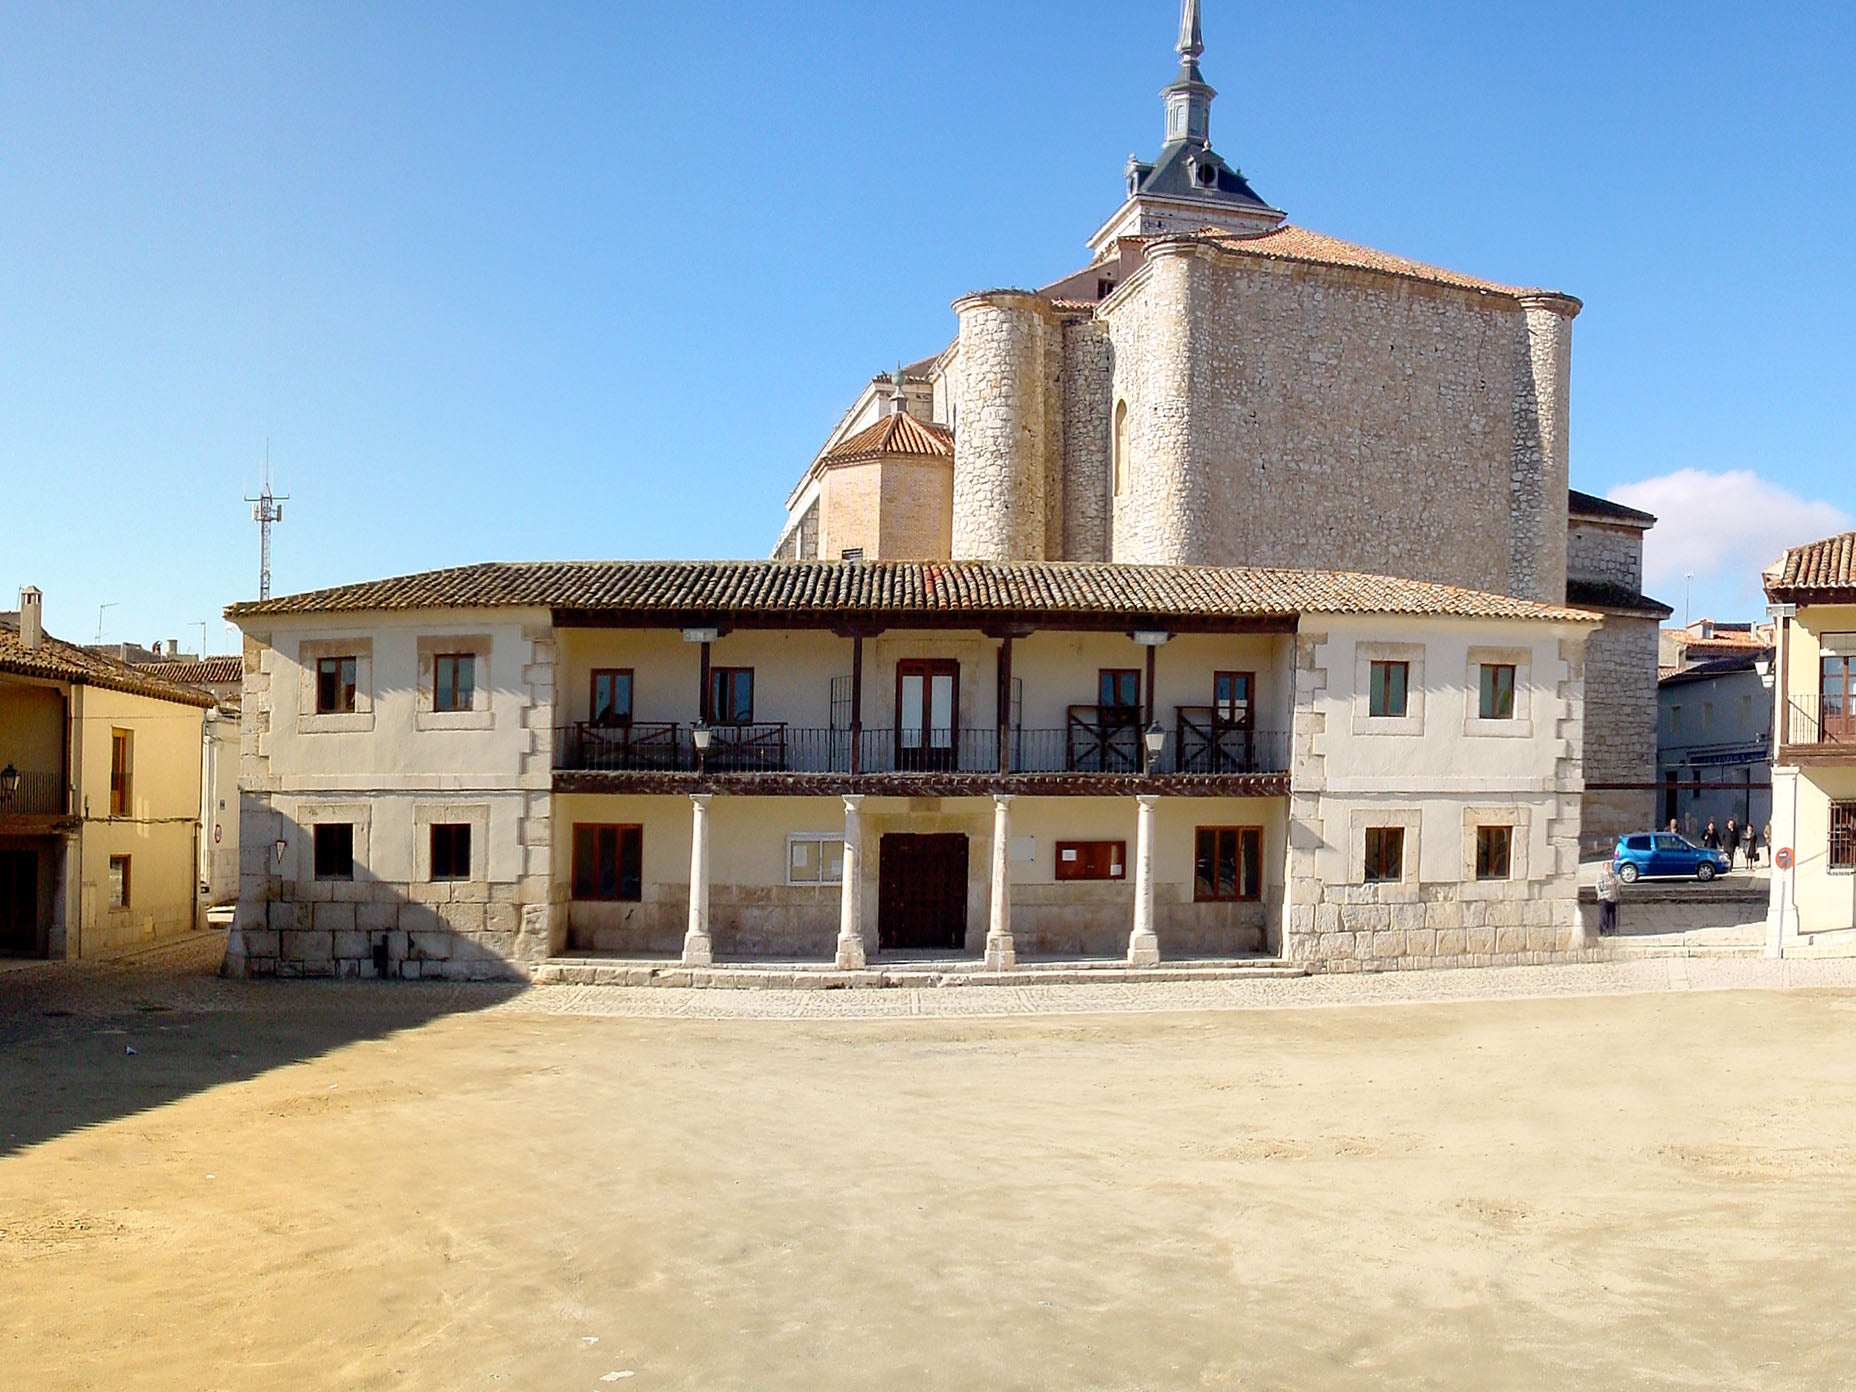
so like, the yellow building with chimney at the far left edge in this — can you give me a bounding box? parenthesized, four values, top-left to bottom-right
(0, 588, 213, 958)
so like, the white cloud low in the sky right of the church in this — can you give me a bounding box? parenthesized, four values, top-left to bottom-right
(1607, 470, 1850, 601)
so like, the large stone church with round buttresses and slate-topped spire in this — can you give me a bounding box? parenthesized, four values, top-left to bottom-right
(774, 0, 1670, 854)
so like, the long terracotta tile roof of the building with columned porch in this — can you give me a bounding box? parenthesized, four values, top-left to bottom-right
(226, 561, 1598, 622)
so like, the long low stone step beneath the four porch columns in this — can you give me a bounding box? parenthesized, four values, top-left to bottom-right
(533, 958, 1308, 991)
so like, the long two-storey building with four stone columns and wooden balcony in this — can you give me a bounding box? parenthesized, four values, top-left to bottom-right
(228, 561, 1598, 976)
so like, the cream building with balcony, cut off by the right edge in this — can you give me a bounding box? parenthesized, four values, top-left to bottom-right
(1765, 533, 1856, 956)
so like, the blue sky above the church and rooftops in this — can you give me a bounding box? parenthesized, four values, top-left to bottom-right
(0, 0, 1856, 651)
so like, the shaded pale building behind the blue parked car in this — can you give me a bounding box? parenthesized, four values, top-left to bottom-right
(1662, 653, 1772, 841)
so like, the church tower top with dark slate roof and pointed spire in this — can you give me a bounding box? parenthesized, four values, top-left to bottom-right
(1089, 0, 1282, 256)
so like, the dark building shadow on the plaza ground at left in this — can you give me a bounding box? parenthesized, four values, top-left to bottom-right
(0, 934, 525, 1156)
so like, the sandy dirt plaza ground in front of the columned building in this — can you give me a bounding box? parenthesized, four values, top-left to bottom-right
(0, 942, 1856, 1392)
